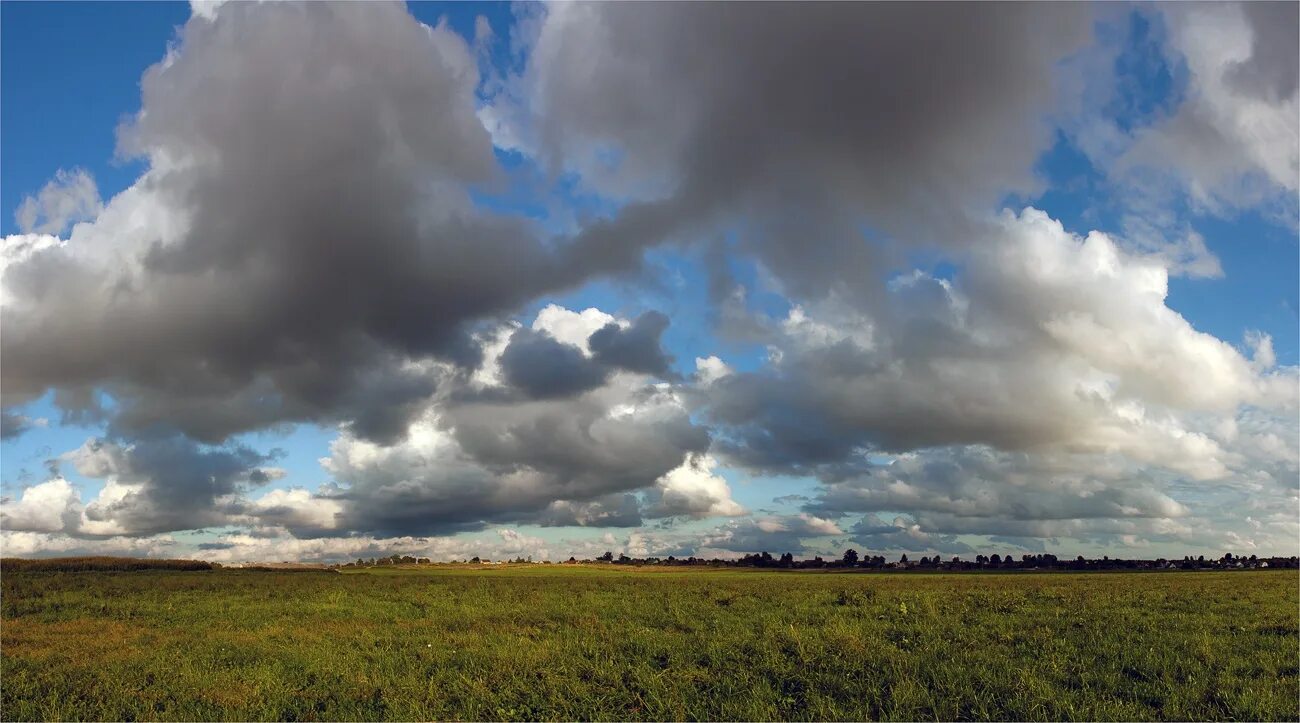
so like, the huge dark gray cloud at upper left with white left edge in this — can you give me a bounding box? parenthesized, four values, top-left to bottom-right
(0, 3, 613, 443)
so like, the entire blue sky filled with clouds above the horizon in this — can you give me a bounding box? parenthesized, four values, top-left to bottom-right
(0, 1, 1300, 562)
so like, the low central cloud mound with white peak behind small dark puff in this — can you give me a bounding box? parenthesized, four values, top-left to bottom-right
(306, 307, 712, 536)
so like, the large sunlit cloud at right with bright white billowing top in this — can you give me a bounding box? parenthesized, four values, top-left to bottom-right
(701, 209, 1296, 480)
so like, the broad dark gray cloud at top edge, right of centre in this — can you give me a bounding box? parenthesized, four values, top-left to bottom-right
(509, 3, 1089, 295)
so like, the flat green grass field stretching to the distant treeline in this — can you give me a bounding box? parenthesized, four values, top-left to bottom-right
(0, 566, 1300, 720)
